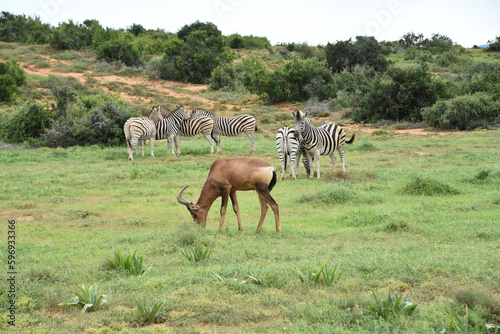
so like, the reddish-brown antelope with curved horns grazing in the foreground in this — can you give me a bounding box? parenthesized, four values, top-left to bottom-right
(177, 157, 281, 232)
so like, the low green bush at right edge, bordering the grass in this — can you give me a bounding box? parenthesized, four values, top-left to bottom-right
(422, 93, 500, 130)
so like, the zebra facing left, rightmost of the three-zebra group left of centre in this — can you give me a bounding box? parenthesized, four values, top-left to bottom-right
(189, 108, 257, 154)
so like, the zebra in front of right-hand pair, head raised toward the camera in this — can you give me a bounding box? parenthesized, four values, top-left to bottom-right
(292, 111, 355, 179)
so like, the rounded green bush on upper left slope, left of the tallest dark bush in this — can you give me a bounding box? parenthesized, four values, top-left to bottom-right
(96, 37, 142, 66)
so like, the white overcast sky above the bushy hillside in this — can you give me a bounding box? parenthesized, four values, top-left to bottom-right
(0, 0, 500, 47)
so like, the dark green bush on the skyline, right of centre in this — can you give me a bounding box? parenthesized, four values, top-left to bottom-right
(325, 36, 389, 72)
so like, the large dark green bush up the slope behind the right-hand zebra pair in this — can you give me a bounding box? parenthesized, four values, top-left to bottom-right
(353, 66, 444, 122)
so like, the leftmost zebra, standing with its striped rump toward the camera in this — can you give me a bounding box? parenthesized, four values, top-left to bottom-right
(123, 106, 163, 160)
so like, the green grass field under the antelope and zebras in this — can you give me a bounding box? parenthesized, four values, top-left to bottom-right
(0, 130, 500, 333)
